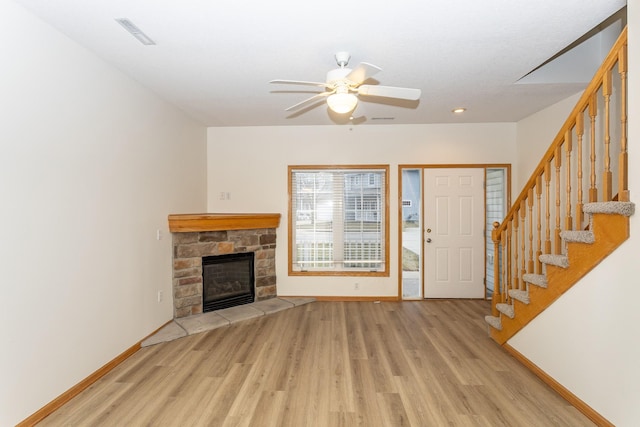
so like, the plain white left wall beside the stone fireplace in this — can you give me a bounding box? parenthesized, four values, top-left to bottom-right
(0, 0, 206, 426)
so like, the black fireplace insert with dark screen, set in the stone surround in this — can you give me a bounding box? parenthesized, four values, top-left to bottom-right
(202, 252, 255, 312)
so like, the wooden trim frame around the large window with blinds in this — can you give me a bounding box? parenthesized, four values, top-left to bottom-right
(287, 164, 390, 277)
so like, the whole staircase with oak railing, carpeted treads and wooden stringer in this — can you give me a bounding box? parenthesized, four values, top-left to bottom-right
(485, 28, 635, 345)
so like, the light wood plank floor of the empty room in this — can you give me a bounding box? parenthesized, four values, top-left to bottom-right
(39, 301, 594, 427)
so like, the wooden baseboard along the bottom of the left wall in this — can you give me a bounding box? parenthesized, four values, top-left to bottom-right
(16, 320, 171, 427)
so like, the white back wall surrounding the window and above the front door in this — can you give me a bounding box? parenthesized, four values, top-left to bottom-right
(207, 123, 515, 296)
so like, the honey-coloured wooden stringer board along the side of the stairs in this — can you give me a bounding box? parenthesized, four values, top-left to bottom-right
(489, 213, 629, 345)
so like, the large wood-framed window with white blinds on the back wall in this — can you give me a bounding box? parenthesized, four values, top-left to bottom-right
(289, 166, 389, 276)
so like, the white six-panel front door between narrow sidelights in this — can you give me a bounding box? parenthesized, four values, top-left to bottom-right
(423, 168, 485, 298)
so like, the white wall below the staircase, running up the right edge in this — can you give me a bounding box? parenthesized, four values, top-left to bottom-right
(509, 6, 640, 427)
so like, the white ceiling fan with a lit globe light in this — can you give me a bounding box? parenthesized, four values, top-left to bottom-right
(269, 52, 422, 114)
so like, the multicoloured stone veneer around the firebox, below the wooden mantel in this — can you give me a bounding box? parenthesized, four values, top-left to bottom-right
(172, 228, 277, 318)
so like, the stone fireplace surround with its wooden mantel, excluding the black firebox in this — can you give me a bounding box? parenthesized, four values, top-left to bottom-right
(169, 214, 280, 318)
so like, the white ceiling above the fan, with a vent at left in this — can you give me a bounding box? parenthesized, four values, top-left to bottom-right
(15, 0, 626, 126)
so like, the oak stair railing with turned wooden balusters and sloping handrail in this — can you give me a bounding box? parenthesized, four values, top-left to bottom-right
(492, 28, 629, 316)
